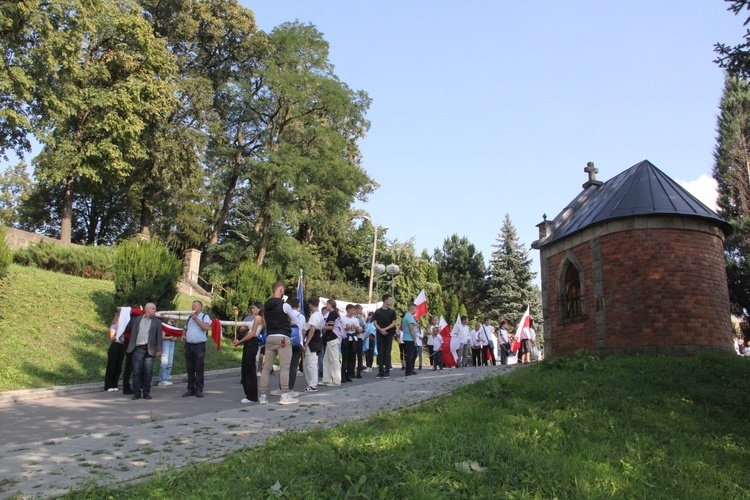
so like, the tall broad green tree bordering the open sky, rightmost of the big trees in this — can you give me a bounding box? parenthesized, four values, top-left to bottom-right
(217, 23, 376, 264)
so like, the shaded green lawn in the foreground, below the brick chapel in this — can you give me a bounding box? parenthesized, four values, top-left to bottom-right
(63, 353, 750, 499)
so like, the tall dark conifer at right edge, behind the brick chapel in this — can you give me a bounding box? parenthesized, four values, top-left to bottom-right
(713, 76, 750, 317)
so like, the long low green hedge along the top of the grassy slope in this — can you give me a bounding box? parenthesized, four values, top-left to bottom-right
(13, 241, 114, 280)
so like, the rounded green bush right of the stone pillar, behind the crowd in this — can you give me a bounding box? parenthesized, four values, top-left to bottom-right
(211, 260, 277, 319)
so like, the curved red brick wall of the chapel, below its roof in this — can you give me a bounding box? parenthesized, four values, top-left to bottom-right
(542, 220, 732, 356)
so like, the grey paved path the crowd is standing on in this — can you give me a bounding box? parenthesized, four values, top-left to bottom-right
(0, 365, 517, 498)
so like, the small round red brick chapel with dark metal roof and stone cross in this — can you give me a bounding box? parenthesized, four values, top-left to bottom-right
(531, 160, 734, 357)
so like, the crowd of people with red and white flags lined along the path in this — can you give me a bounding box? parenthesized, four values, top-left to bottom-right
(104, 282, 536, 405)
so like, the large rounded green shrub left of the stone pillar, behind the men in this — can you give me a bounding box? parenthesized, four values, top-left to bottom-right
(113, 239, 182, 310)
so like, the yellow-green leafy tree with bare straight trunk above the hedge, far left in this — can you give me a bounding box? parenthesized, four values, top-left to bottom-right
(25, 0, 176, 242)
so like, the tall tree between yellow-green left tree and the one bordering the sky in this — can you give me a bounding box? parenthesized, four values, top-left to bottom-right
(140, 0, 258, 244)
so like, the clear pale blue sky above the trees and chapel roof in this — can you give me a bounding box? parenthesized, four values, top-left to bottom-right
(245, 0, 744, 282)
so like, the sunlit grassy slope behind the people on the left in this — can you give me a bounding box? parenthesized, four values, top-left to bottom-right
(0, 264, 242, 391)
